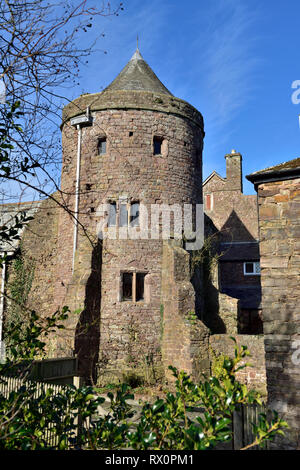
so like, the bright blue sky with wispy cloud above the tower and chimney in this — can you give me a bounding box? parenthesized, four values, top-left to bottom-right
(63, 0, 300, 194)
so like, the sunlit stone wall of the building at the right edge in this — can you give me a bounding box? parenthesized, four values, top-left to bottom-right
(258, 178, 300, 449)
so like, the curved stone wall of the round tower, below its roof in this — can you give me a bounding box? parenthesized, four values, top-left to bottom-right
(55, 92, 203, 383)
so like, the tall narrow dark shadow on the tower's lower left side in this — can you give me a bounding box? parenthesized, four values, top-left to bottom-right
(75, 240, 102, 384)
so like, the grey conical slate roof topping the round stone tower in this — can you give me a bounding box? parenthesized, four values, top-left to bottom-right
(104, 48, 173, 96)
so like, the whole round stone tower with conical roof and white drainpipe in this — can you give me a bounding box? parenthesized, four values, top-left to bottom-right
(56, 49, 207, 382)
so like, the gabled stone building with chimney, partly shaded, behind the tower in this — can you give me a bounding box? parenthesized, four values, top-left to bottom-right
(203, 151, 261, 334)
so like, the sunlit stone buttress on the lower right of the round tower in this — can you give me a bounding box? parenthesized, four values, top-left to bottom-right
(161, 241, 209, 380)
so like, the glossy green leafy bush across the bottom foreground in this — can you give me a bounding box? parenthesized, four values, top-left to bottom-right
(0, 308, 287, 450)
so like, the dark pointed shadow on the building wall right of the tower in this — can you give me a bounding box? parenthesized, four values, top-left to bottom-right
(192, 211, 262, 334)
